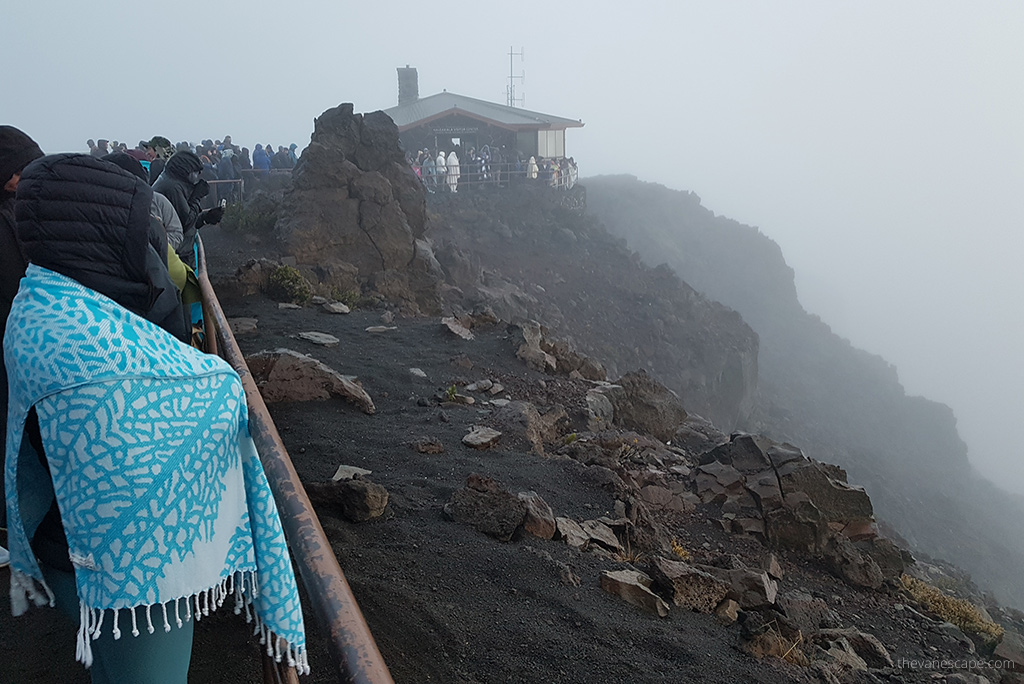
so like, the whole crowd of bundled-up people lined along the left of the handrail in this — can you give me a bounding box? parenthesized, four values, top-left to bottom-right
(0, 126, 308, 684)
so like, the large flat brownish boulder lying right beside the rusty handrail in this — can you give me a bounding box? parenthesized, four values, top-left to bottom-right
(246, 349, 377, 414)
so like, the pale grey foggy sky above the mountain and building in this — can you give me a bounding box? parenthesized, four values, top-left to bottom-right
(0, 0, 1024, 490)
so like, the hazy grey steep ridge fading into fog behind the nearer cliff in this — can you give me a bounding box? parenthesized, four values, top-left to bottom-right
(586, 176, 1024, 605)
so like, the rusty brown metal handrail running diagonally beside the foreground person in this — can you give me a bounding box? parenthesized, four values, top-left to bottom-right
(198, 240, 394, 684)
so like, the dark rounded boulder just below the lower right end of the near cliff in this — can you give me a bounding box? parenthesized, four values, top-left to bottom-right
(596, 371, 686, 441)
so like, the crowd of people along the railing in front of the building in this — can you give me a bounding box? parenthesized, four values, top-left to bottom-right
(406, 144, 580, 193)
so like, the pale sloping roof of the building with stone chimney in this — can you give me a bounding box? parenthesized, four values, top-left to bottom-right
(384, 91, 583, 132)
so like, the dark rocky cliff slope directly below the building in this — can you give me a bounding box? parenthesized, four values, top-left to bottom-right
(427, 186, 758, 429)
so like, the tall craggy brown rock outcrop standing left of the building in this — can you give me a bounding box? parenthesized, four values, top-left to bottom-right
(276, 104, 437, 311)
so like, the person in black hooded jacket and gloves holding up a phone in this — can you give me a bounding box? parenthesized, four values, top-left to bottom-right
(153, 152, 224, 264)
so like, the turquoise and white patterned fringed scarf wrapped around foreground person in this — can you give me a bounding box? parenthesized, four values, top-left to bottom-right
(4, 265, 309, 673)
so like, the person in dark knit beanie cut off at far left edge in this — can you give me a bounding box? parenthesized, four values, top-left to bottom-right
(0, 126, 44, 567)
